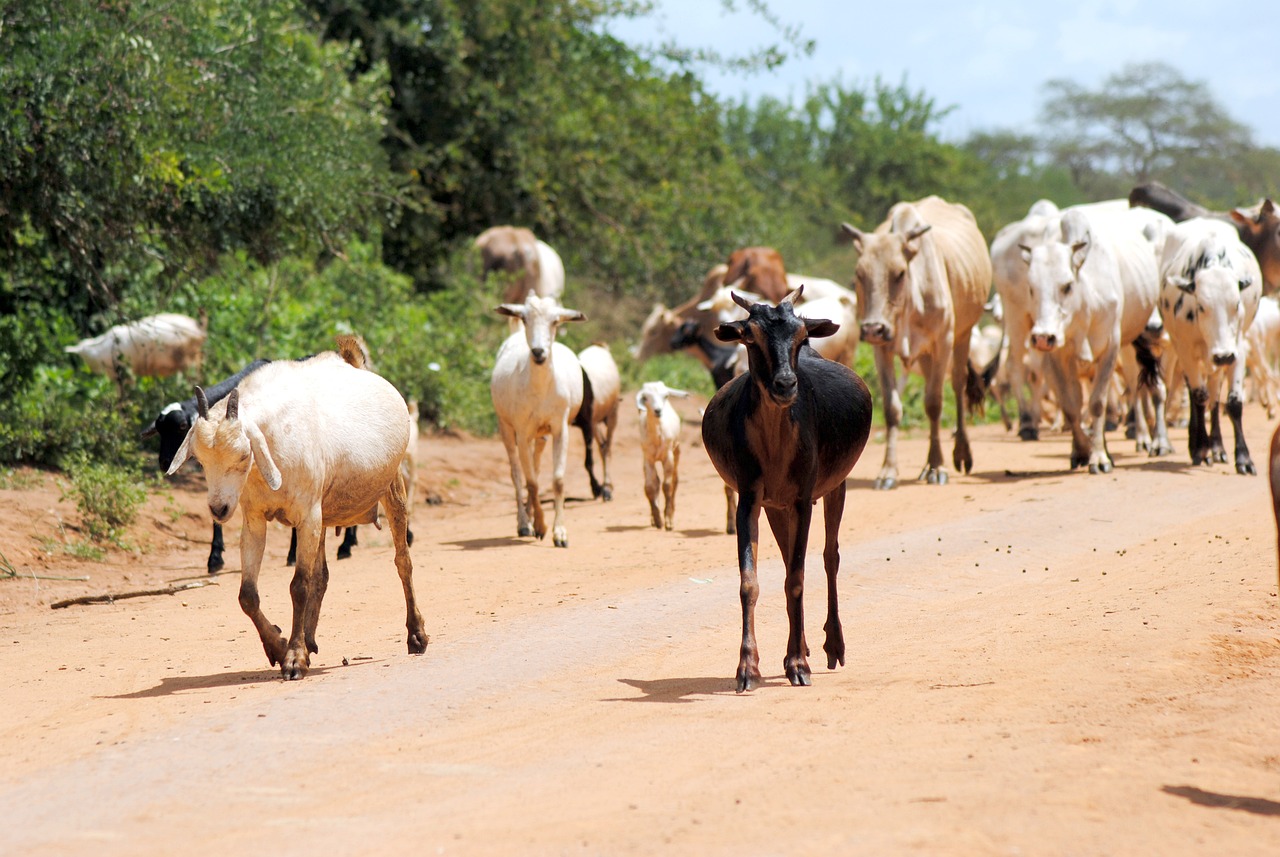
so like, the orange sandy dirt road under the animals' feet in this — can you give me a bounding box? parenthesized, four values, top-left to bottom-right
(0, 407, 1280, 854)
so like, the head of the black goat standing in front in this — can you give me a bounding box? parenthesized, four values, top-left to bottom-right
(716, 285, 840, 405)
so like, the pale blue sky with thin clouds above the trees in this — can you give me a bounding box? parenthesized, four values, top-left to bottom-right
(608, 0, 1280, 147)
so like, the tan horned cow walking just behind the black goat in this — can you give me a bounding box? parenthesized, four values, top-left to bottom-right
(841, 197, 991, 490)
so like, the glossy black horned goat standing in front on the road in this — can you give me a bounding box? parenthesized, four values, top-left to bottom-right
(703, 293, 872, 693)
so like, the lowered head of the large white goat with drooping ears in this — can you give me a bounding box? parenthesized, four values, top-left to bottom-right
(169, 386, 282, 523)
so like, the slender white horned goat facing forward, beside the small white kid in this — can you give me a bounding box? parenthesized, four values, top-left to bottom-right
(489, 294, 586, 547)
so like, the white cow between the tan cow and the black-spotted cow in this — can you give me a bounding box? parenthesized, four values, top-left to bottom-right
(1005, 202, 1171, 473)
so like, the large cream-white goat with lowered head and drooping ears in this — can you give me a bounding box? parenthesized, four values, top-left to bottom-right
(169, 340, 428, 679)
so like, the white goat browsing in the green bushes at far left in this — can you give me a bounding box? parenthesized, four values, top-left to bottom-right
(64, 312, 205, 381)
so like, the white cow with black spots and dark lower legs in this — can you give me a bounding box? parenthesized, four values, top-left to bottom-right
(1160, 217, 1262, 475)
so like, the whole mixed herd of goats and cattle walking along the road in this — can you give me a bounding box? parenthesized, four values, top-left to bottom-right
(60, 184, 1280, 691)
